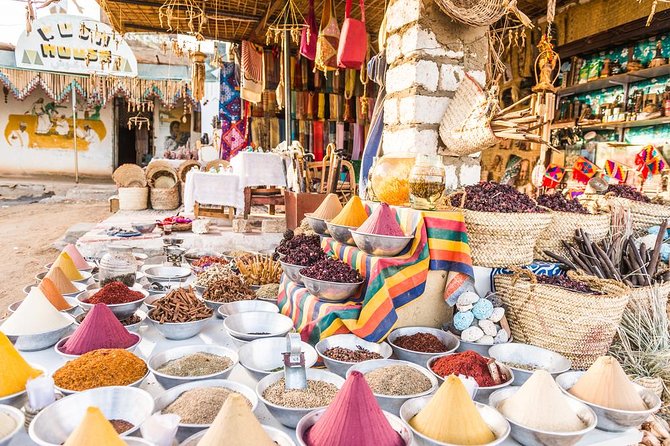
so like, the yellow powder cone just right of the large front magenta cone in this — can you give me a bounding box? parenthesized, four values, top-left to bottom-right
(409, 375, 496, 445)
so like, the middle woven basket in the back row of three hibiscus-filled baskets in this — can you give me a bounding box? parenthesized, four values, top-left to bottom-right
(535, 212, 611, 260)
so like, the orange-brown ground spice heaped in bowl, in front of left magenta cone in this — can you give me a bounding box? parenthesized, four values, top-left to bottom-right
(53, 348, 149, 395)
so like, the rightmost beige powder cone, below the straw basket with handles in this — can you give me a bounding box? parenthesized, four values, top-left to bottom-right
(569, 356, 647, 410)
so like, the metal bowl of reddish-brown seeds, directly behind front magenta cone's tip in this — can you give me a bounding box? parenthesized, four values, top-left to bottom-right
(315, 334, 393, 378)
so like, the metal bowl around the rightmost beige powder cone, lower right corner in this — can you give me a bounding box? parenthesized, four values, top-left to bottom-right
(556, 372, 661, 432)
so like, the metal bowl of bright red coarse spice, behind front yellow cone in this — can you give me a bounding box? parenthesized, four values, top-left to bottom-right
(426, 351, 514, 401)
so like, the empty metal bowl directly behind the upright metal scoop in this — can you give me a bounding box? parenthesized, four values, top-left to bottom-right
(237, 337, 318, 380)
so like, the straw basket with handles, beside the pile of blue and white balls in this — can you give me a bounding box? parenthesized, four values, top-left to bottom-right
(494, 269, 630, 369)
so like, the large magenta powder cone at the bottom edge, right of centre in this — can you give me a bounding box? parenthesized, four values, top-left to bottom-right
(305, 372, 406, 446)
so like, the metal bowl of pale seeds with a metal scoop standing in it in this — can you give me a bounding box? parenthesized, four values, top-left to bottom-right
(256, 369, 344, 429)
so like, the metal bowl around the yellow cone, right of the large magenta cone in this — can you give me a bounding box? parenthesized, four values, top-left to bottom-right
(400, 395, 512, 446)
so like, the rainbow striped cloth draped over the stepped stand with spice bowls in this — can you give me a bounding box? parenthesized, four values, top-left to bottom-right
(277, 208, 474, 344)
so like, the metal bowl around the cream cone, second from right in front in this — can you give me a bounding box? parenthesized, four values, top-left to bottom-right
(489, 386, 598, 446)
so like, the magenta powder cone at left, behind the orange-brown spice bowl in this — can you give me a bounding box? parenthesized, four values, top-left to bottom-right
(60, 304, 139, 355)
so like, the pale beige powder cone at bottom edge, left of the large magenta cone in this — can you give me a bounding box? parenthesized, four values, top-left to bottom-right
(198, 394, 276, 446)
